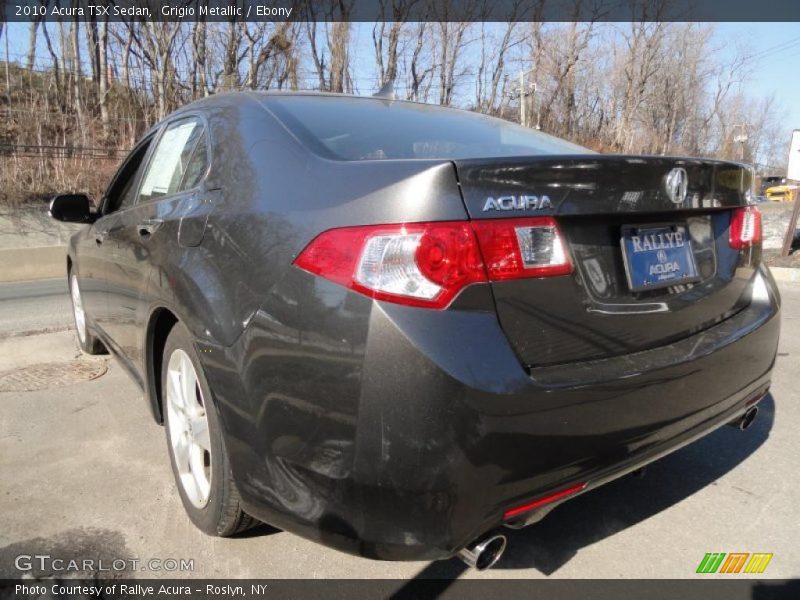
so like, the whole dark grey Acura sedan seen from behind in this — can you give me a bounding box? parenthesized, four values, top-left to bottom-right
(50, 92, 780, 568)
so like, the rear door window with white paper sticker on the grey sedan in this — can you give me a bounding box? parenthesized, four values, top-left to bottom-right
(139, 118, 205, 202)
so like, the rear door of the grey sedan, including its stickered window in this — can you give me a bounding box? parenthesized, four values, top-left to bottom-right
(101, 116, 208, 367)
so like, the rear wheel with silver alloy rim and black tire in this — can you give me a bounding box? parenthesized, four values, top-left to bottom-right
(161, 323, 258, 537)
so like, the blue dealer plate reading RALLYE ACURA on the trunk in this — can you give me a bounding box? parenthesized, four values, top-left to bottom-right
(621, 224, 700, 292)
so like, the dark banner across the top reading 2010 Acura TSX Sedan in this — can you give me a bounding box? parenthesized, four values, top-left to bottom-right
(0, 0, 800, 22)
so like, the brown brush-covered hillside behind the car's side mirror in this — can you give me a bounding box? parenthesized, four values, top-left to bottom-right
(0, 62, 148, 206)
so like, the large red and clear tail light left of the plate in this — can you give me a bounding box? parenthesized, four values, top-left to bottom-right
(294, 217, 572, 308)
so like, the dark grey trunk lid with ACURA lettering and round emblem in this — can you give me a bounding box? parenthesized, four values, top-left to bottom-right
(455, 155, 760, 368)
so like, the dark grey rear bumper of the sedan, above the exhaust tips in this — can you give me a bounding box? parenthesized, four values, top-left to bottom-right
(201, 268, 780, 560)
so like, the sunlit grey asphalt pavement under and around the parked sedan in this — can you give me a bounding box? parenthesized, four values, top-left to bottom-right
(0, 281, 800, 579)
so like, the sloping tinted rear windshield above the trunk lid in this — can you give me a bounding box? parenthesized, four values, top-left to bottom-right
(266, 96, 592, 160)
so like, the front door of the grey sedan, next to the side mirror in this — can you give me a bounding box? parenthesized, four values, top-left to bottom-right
(83, 135, 159, 333)
